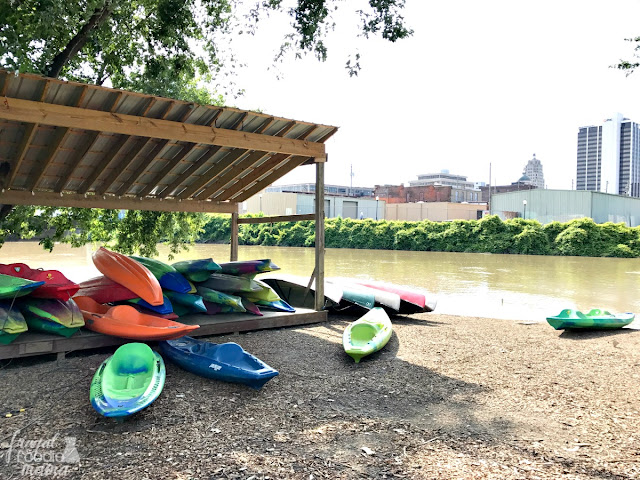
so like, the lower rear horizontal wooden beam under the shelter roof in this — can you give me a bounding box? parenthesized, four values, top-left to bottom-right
(0, 190, 238, 213)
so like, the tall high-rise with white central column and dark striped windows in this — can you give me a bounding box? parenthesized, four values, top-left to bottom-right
(576, 113, 640, 197)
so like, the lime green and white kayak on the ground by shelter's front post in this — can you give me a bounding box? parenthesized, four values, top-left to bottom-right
(342, 307, 393, 363)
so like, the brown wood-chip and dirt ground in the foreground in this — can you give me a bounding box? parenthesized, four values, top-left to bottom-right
(0, 313, 640, 480)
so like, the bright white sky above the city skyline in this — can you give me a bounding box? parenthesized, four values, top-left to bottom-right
(230, 0, 640, 189)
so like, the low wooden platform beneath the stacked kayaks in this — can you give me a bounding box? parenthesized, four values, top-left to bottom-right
(0, 308, 328, 360)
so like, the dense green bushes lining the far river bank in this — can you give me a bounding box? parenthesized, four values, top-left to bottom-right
(198, 215, 640, 258)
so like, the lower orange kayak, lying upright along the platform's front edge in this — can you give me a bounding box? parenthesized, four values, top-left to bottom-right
(73, 296, 200, 341)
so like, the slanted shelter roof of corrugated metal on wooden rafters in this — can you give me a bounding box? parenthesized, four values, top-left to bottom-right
(0, 69, 337, 213)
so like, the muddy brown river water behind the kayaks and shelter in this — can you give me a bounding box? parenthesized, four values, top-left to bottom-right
(0, 242, 640, 323)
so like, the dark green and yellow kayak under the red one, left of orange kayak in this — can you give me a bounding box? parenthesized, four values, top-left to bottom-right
(16, 297, 84, 337)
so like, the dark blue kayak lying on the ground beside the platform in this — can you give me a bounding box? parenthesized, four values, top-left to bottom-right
(159, 336, 278, 390)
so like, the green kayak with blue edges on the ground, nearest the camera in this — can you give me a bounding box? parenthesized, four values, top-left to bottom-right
(89, 343, 166, 417)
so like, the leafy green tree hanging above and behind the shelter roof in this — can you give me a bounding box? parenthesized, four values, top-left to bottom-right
(0, 0, 412, 255)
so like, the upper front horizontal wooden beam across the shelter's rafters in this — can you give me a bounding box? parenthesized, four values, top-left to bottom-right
(0, 98, 325, 157)
